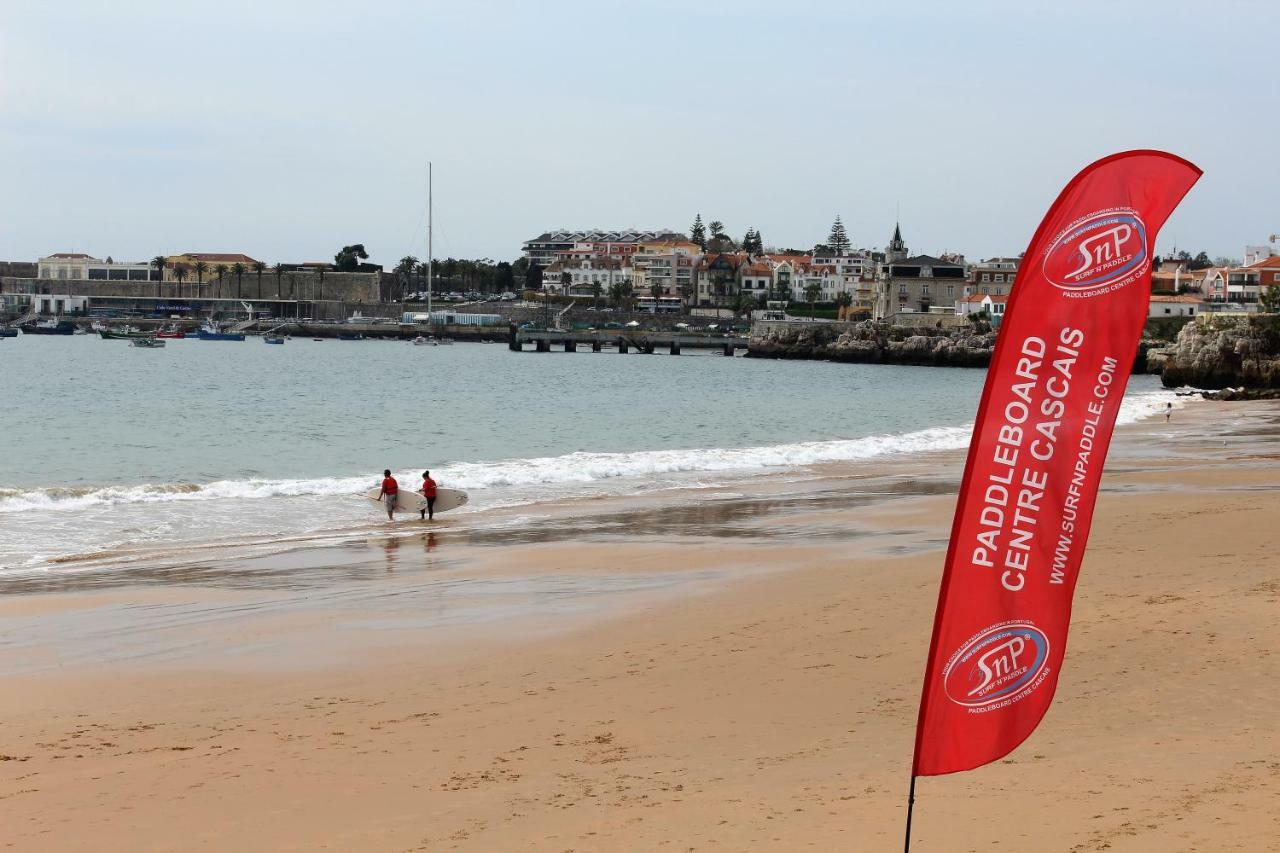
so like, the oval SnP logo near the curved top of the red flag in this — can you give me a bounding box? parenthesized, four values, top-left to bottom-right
(1043, 210, 1147, 291)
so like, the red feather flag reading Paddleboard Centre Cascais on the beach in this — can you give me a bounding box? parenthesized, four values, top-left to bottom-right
(913, 151, 1201, 773)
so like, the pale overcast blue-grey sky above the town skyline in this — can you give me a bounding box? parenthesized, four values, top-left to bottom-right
(0, 0, 1280, 264)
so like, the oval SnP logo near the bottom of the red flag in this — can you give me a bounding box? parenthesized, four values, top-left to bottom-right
(942, 621, 1048, 708)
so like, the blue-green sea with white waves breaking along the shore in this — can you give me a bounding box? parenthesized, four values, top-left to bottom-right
(0, 336, 1176, 575)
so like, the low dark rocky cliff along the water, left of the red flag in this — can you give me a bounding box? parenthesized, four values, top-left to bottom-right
(748, 320, 996, 368)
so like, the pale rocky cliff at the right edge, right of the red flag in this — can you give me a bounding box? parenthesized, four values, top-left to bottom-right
(1147, 314, 1280, 388)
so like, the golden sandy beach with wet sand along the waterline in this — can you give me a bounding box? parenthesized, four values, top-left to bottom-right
(0, 402, 1280, 853)
